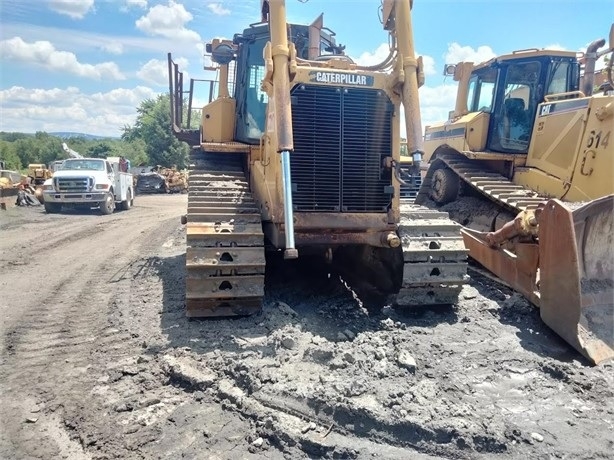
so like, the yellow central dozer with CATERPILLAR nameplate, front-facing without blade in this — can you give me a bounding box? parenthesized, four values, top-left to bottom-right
(168, 0, 467, 317)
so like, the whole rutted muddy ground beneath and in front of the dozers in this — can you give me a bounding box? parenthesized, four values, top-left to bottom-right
(0, 195, 614, 459)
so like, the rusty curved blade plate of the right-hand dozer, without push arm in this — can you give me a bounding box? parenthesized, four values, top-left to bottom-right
(539, 195, 614, 364)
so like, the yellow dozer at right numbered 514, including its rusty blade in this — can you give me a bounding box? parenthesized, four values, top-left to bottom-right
(416, 25, 614, 363)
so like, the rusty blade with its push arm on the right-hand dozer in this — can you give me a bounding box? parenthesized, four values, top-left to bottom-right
(461, 195, 614, 364)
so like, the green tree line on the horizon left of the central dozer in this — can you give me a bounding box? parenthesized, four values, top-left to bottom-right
(0, 95, 189, 172)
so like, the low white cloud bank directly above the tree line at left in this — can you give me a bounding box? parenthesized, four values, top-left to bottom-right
(0, 86, 157, 137)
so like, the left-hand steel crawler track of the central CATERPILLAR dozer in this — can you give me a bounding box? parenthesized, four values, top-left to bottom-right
(186, 150, 265, 317)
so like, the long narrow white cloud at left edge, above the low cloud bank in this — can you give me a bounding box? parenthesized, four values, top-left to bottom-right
(0, 37, 125, 80)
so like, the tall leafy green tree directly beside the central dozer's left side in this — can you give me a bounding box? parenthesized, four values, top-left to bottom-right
(122, 95, 189, 169)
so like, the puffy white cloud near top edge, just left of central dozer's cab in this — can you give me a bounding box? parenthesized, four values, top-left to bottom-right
(136, 0, 201, 42)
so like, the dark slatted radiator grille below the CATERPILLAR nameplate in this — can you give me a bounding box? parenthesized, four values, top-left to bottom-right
(290, 85, 393, 212)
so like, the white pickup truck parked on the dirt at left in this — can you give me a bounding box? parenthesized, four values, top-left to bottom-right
(43, 157, 134, 214)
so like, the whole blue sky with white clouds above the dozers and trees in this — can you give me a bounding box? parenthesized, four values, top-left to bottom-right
(0, 0, 614, 136)
